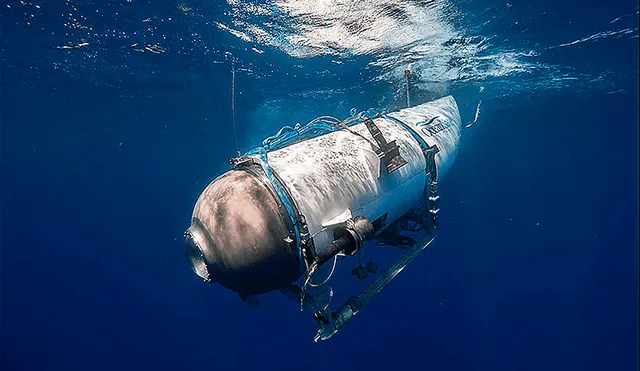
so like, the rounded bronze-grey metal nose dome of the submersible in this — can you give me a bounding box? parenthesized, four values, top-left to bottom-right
(185, 167, 301, 295)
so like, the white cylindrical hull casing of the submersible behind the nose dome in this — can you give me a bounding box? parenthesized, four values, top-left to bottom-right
(267, 96, 461, 252)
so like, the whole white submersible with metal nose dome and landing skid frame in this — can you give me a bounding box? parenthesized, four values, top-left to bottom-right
(185, 96, 462, 341)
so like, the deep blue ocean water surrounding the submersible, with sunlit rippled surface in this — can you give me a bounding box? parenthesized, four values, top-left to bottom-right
(0, 0, 638, 371)
